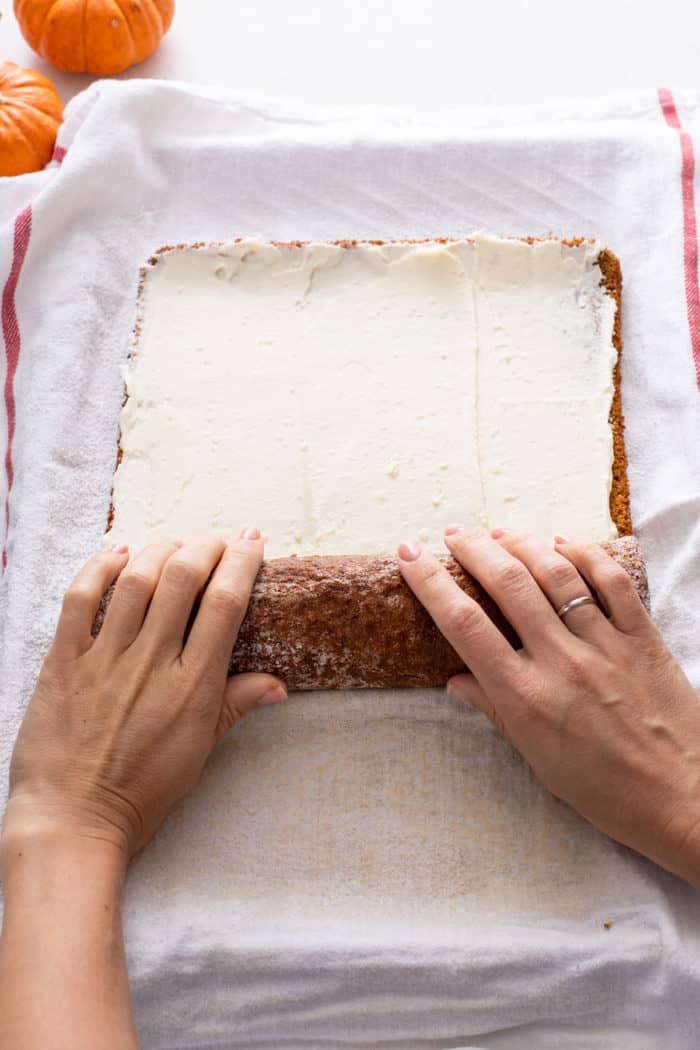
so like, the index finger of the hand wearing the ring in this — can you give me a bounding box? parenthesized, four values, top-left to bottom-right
(399, 543, 519, 690)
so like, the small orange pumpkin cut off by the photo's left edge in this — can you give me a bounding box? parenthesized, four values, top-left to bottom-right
(0, 62, 63, 175)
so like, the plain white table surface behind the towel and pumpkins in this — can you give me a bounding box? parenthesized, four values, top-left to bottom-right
(0, 0, 700, 110)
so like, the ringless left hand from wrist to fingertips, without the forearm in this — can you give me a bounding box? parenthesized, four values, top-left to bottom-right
(3, 529, 287, 859)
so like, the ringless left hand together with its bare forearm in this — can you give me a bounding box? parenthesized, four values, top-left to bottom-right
(0, 529, 287, 1050)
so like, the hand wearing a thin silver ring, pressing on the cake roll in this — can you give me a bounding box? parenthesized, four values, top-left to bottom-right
(399, 526, 700, 886)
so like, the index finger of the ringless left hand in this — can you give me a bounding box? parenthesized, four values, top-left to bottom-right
(183, 528, 262, 674)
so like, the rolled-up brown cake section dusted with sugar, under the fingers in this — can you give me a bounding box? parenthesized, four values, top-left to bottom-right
(93, 537, 649, 690)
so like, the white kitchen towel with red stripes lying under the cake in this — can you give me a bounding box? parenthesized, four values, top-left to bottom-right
(0, 81, 700, 1050)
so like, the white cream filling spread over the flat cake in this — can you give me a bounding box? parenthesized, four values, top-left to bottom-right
(105, 234, 616, 557)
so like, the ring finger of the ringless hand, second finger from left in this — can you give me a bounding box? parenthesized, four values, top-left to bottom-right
(96, 540, 181, 652)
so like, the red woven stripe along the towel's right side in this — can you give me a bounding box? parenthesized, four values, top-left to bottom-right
(659, 87, 700, 389)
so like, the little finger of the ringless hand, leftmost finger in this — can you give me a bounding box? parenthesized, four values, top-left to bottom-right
(54, 544, 129, 657)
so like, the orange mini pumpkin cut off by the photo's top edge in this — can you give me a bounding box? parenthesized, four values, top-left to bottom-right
(15, 0, 175, 77)
